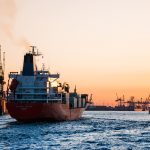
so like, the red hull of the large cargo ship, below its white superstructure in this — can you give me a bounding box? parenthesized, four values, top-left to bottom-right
(6, 101, 85, 122)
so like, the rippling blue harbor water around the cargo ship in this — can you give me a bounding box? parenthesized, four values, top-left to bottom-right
(0, 111, 150, 150)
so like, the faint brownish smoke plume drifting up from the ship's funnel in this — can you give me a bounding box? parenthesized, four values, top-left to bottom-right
(0, 0, 31, 49)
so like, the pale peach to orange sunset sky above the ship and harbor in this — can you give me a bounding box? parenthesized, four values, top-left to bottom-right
(0, 0, 150, 105)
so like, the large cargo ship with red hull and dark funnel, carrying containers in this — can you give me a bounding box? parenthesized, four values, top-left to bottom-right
(6, 46, 90, 122)
